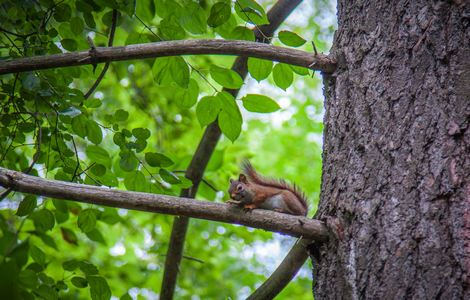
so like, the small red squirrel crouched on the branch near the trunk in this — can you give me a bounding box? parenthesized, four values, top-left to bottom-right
(227, 161, 308, 216)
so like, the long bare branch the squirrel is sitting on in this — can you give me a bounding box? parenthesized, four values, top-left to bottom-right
(0, 168, 328, 241)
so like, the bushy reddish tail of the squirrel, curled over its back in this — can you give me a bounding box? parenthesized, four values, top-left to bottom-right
(242, 160, 308, 209)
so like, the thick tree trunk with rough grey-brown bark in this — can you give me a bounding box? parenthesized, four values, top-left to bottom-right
(312, 0, 470, 299)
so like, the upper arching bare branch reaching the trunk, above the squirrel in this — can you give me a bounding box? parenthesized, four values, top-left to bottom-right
(0, 40, 335, 75)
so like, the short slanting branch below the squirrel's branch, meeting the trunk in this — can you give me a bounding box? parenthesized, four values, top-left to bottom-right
(247, 239, 312, 300)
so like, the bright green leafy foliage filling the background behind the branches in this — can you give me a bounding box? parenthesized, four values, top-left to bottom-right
(0, 0, 338, 299)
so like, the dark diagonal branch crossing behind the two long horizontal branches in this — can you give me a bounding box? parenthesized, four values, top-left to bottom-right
(160, 0, 302, 300)
